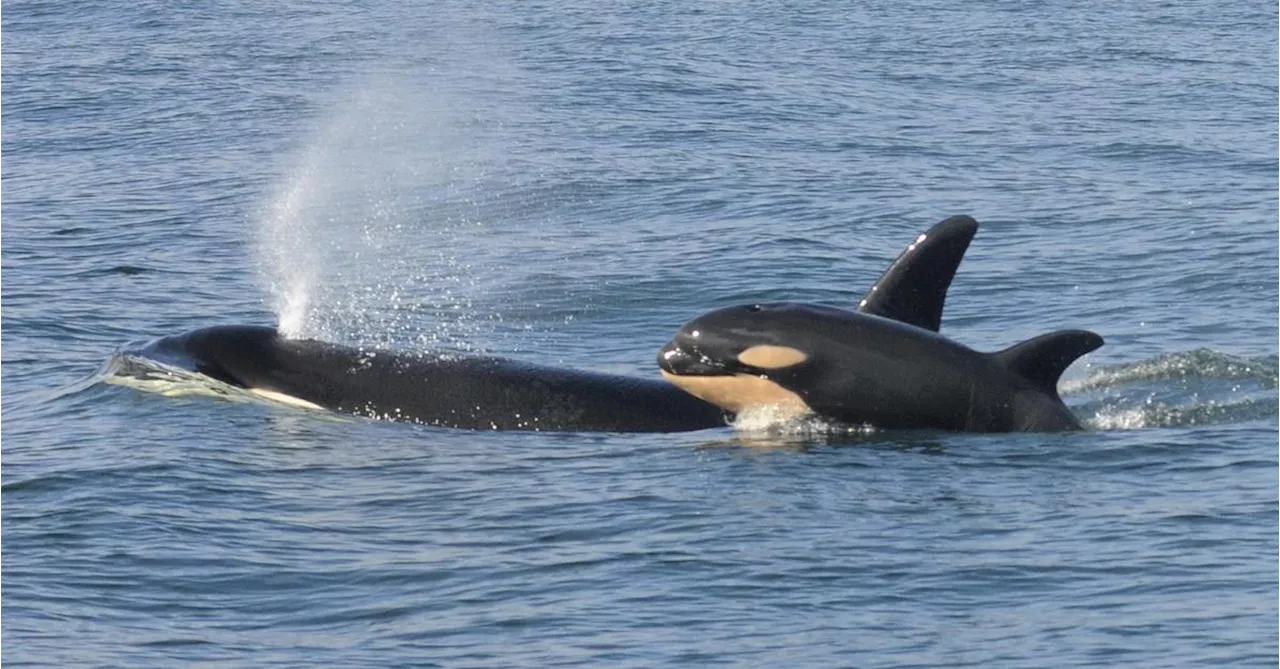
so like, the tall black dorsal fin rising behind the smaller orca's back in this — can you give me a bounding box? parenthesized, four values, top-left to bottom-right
(858, 216, 978, 333)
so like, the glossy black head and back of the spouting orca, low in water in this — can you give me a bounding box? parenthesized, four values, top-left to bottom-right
(143, 326, 726, 432)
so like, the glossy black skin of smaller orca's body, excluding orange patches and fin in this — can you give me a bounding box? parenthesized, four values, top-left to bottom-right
(658, 303, 1101, 432)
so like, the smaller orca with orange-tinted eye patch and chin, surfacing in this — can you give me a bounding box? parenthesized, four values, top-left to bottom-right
(658, 219, 1102, 432)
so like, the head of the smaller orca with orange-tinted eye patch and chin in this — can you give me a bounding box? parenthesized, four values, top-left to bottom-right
(658, 302, 850, 418)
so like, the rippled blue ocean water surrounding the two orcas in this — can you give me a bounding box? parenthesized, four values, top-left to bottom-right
(0, 0, 1280, 668)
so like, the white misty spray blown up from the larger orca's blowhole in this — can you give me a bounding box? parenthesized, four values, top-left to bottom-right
(257, 75, 499, 348)
